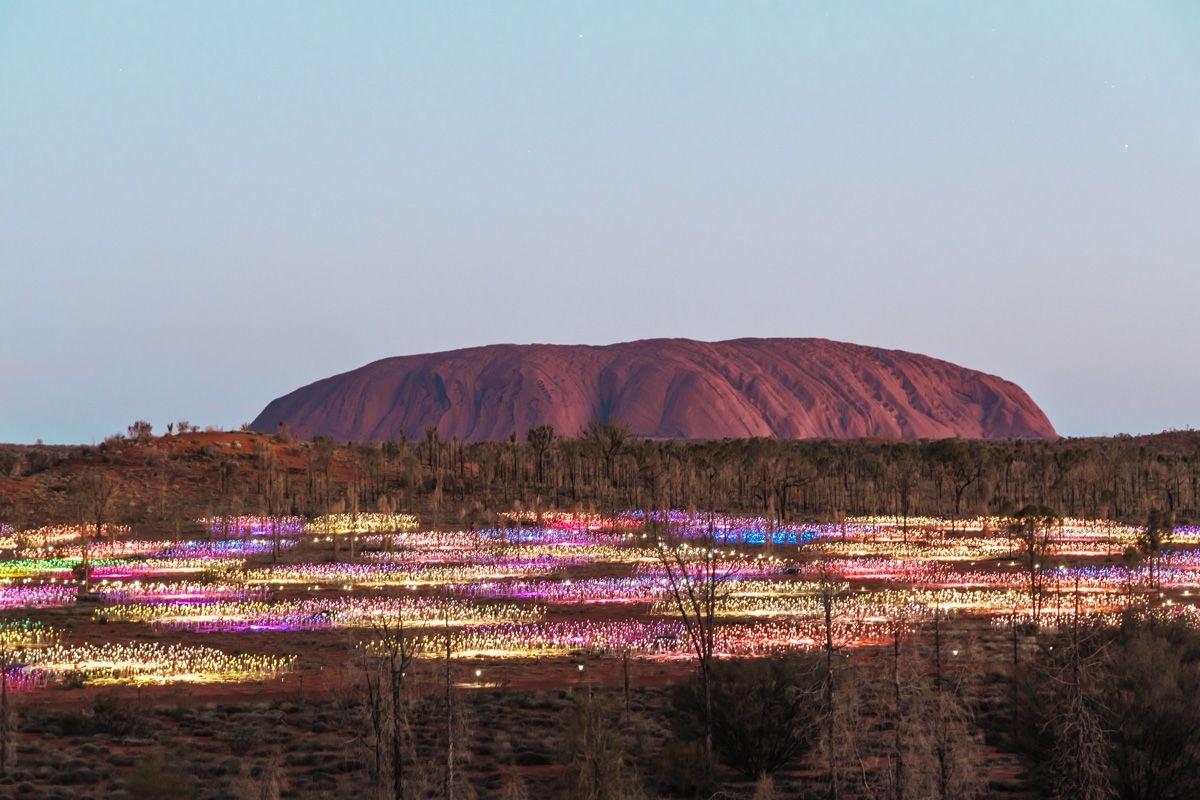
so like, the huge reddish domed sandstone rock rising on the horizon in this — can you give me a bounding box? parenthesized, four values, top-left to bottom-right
(252, 338, 1056, 441)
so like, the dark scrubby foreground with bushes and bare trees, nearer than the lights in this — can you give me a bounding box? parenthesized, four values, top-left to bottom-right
(7, 613, 1200, 800)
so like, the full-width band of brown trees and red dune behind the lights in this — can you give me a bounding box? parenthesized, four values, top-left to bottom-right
(0, 422, 1200, 527)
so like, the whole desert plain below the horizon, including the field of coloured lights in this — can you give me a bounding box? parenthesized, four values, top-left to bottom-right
(0, 422, 1200, 798)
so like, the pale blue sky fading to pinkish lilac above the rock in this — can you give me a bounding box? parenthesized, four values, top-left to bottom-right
(0, 0, 1200, 443)
